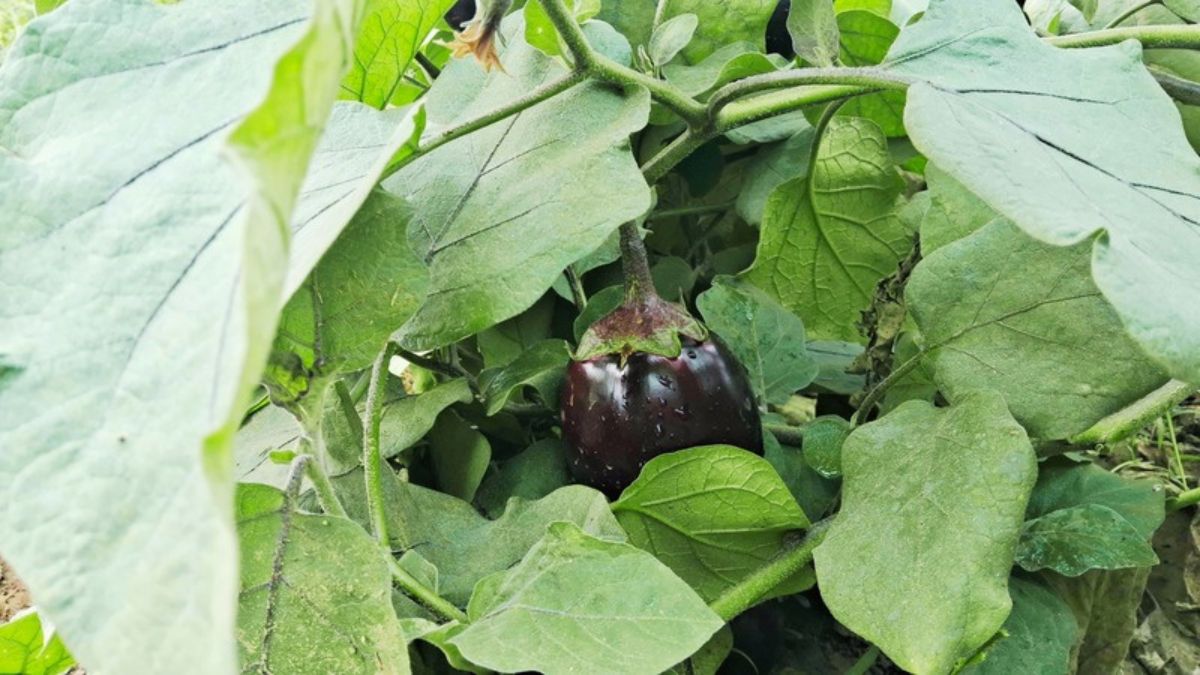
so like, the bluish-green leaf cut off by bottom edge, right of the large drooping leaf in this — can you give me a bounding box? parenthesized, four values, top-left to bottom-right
(961, 577, 1079, 675)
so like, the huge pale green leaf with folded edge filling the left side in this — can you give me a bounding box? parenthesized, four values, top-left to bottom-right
(0, 0, 356, 675)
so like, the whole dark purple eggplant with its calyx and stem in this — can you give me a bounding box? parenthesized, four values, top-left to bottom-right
(562, 228, 762, 497)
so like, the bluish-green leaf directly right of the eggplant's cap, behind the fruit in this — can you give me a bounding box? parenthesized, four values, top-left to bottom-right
(696, 277, 817, 405)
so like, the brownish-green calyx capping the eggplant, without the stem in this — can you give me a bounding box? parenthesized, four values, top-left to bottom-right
(575, 293, 708, 363)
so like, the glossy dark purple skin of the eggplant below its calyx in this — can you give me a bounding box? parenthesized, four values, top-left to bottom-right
(562, 336, 762, 497)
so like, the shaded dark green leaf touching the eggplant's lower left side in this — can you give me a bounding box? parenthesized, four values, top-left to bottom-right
(475, 438, 571, 518)
